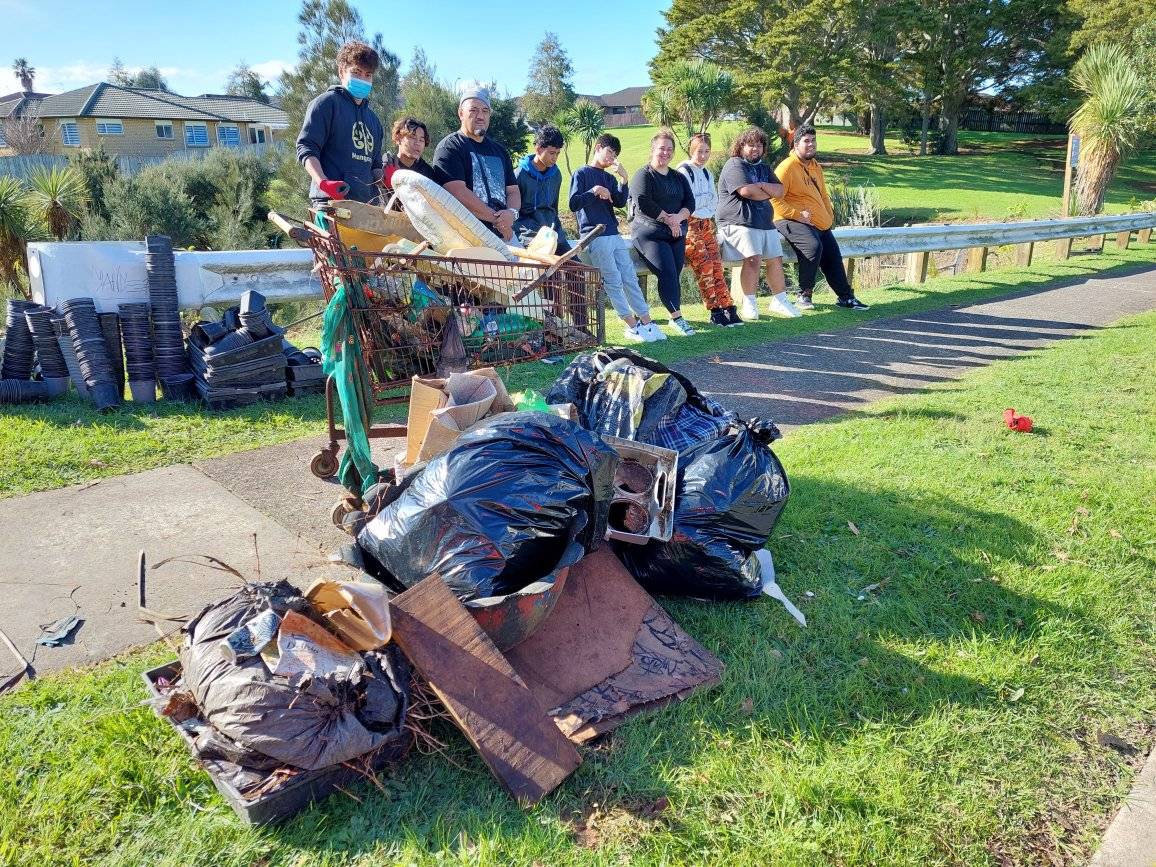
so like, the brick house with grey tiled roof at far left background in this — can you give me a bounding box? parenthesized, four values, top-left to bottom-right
(0, 82, 288, 157)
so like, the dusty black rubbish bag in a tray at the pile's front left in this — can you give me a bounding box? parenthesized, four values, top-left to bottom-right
(180, 581, 410, 770)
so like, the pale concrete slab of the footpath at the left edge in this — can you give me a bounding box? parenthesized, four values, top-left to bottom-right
(0, 466, 346, 684)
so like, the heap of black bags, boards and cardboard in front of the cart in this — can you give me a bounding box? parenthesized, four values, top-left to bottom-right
(142, 351, 805, 821)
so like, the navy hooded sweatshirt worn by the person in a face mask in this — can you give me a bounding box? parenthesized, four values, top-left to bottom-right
(297, 84, 385, 202)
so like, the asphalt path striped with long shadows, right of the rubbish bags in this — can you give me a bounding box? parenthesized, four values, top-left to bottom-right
(674, 264, 1156, 430)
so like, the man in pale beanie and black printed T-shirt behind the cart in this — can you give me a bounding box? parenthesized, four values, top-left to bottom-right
(434, 82, 521, 242)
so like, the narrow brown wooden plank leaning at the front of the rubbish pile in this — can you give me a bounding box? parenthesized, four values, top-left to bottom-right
(390, 575, 581, 805)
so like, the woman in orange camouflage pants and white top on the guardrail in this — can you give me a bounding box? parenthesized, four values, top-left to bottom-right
(679, 133, 742, 326)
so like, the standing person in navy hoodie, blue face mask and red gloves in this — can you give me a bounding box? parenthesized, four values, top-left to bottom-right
(297, 39, 385, 202)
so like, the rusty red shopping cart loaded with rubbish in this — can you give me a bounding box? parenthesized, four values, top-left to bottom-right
(269, 209, 606, 479)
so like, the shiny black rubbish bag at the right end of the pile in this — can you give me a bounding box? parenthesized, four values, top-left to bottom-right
(613, 423, 790, 600)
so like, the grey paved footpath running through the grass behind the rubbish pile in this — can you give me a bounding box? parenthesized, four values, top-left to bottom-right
(0, 268, 1156, 867)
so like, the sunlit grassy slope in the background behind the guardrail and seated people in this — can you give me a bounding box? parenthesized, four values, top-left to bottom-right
(558, 123, 1156, 225)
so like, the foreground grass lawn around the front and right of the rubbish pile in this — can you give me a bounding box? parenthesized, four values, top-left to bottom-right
(0, 313, 1156, 867)
